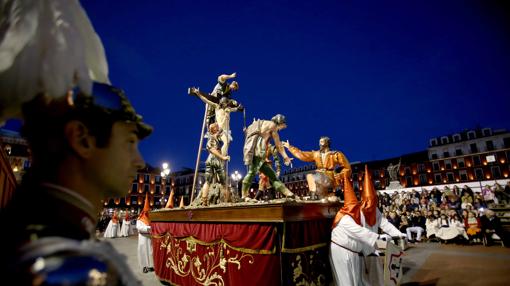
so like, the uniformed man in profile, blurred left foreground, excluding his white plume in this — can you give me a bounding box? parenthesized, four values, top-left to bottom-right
(0, 83, 152, 285)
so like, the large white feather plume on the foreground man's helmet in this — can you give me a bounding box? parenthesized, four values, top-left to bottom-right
(0, 0, 109, 121)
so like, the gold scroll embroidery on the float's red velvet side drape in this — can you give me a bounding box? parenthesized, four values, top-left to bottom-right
(155, 233, 266, 286)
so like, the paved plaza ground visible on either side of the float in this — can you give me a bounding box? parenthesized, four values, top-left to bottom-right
(108, 236, 510, 286)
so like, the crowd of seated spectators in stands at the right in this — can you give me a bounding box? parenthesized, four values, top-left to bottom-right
(379, 181, 510, 246)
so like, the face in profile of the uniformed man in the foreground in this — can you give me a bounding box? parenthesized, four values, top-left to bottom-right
(88, 121, 145, 196)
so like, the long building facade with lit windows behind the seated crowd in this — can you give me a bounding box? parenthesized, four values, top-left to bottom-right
(281, 128, 510, 196)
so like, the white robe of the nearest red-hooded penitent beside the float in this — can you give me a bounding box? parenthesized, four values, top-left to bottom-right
(329, 215, 378, 286)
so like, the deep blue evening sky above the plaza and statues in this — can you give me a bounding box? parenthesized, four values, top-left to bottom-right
(9, 0, 510, 173)
